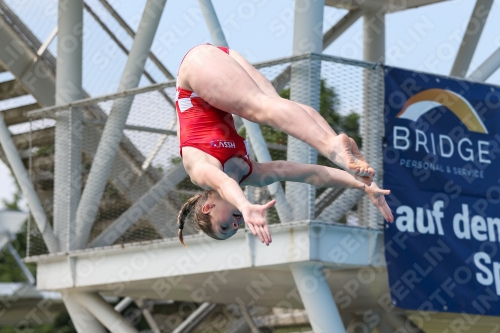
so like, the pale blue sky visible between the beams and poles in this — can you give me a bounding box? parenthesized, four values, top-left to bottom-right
(0, 0, 500, 208)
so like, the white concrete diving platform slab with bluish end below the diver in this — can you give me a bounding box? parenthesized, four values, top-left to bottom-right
(26, 221, 389, 312)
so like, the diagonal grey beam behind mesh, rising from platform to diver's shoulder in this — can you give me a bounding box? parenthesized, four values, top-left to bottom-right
(90, 164, 187, 247)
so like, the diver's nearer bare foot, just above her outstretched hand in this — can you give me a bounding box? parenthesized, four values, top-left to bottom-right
(330, 134, 375, 180)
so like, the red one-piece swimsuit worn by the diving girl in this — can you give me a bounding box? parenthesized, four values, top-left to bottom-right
(175, 46, 252, 183)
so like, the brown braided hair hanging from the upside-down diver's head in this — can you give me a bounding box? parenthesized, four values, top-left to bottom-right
(177, 191, 219, 247)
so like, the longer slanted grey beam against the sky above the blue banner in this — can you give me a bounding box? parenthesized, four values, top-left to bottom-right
(450, 0, 493, 77)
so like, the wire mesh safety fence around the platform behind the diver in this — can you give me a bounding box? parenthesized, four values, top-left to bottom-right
(16, 55, 383, 256)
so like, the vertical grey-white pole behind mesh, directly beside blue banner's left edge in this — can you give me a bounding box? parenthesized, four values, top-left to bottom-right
(358, 11, 385, 228)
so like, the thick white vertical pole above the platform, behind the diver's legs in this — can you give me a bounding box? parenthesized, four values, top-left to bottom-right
(286, 0, 324, 220)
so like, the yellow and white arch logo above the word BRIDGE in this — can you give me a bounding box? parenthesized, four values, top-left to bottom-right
(396, 89, 488, 134)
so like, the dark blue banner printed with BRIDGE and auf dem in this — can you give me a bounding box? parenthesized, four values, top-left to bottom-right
(383, 67, 500, 316)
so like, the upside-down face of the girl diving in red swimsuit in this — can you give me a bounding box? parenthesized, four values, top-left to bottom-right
(202, 193, 243, 239)
